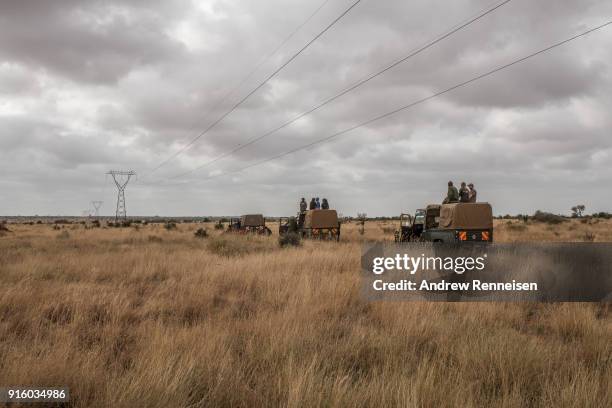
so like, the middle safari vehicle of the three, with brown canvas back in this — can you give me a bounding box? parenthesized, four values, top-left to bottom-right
(278, 210, 340, 241)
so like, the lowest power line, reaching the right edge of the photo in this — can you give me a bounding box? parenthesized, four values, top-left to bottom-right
(164, 20, 612, 181)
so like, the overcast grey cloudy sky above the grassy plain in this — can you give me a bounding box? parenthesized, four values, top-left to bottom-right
(0, 0, 612, 215)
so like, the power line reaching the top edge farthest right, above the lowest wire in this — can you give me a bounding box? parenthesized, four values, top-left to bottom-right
(169, 0, 512, 180)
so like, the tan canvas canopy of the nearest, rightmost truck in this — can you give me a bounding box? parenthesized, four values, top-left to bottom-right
(439, 203, 493, 229)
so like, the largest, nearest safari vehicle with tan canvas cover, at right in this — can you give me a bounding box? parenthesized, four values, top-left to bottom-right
(396, 203, 493, 243)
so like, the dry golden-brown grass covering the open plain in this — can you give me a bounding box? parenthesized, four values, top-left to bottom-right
(0, 221, 612, 407)
